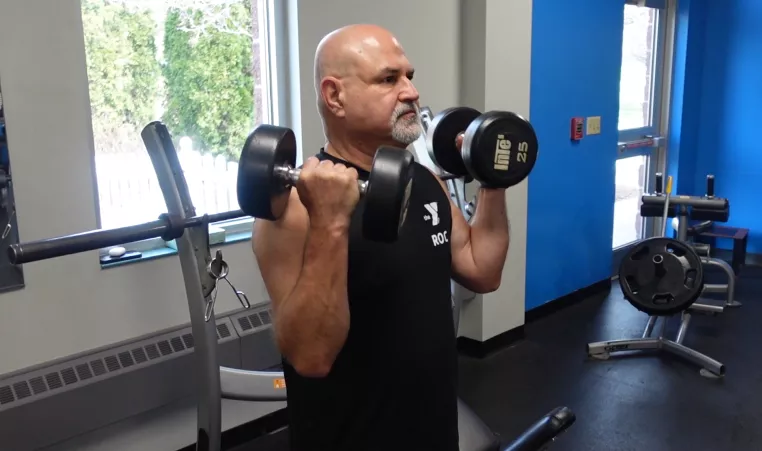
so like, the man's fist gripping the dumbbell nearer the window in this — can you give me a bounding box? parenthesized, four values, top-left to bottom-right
(296, 157, 360, 229)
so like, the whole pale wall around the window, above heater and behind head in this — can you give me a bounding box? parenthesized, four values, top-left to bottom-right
(0, 0, 459, 374)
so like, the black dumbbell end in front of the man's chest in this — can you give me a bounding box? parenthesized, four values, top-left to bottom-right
(362, 147, 415, 243)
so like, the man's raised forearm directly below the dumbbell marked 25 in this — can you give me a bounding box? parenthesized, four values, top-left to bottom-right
(470, 188, 510, 282)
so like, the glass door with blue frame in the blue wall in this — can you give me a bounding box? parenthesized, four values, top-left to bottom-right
(612, 2, 674, 274)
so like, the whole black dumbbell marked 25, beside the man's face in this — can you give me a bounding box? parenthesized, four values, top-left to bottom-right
(426, 107, 539, 188)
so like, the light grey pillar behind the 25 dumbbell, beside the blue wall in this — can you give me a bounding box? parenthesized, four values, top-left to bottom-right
(460, 0, 532, 341)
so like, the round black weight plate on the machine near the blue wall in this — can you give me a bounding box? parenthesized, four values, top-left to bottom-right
(619, 237, 704, 316)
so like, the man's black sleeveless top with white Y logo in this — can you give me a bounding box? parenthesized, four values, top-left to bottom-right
(283, 149, 458, 451)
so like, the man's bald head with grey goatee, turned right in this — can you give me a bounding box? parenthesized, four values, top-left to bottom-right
(315, 24, 421, 152)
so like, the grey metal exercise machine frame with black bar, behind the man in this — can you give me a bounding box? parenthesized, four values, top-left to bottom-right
(8, 118, 574, 451)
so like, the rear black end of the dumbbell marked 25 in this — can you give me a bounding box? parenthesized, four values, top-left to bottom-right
(426, 107, 481, 177)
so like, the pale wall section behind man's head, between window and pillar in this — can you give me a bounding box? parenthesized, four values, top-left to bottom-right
(292, 0, 460, 157)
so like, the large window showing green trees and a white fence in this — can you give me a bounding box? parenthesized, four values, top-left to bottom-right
(82, 0, 277, 246)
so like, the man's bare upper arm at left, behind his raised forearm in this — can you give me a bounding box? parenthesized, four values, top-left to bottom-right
(252, 190, 309, 310)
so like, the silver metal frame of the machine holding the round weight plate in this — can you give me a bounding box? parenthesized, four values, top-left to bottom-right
(587, 174, 740, 378)
